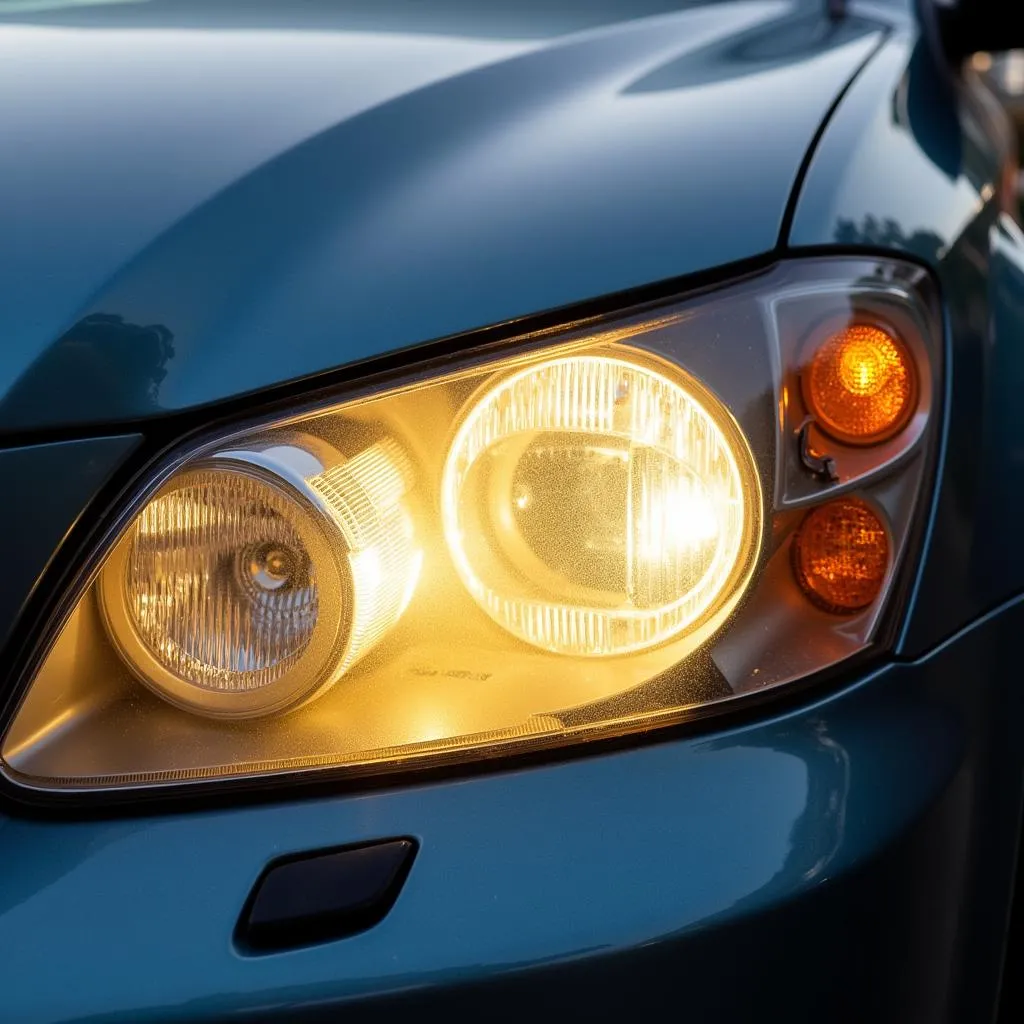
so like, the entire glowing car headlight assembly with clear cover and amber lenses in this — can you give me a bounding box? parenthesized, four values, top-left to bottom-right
(0, 259, 942, 791)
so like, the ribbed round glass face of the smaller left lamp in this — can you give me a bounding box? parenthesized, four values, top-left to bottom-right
(125, 471, 317, 691)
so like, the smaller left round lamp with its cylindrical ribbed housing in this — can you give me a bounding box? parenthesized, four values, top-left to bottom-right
(99, 437, 421, 718)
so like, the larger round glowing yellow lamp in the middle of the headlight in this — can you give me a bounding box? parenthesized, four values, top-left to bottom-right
(441, 354, 761, 655)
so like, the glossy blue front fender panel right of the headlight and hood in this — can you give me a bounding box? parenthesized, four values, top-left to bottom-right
(788, 31, 1024, 654)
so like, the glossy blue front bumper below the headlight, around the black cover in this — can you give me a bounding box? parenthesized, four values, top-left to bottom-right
(0, 601, 1024, 1024)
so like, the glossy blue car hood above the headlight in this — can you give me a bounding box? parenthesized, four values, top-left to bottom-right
(0, 0, 882, 434)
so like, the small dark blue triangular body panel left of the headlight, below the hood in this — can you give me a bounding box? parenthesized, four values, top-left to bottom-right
(0, 434, 141, 654)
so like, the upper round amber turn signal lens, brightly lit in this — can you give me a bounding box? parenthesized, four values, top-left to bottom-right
(803, 324, 918, 444)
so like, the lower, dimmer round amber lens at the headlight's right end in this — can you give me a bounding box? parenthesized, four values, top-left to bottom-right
(793, 498, 889, 614)
